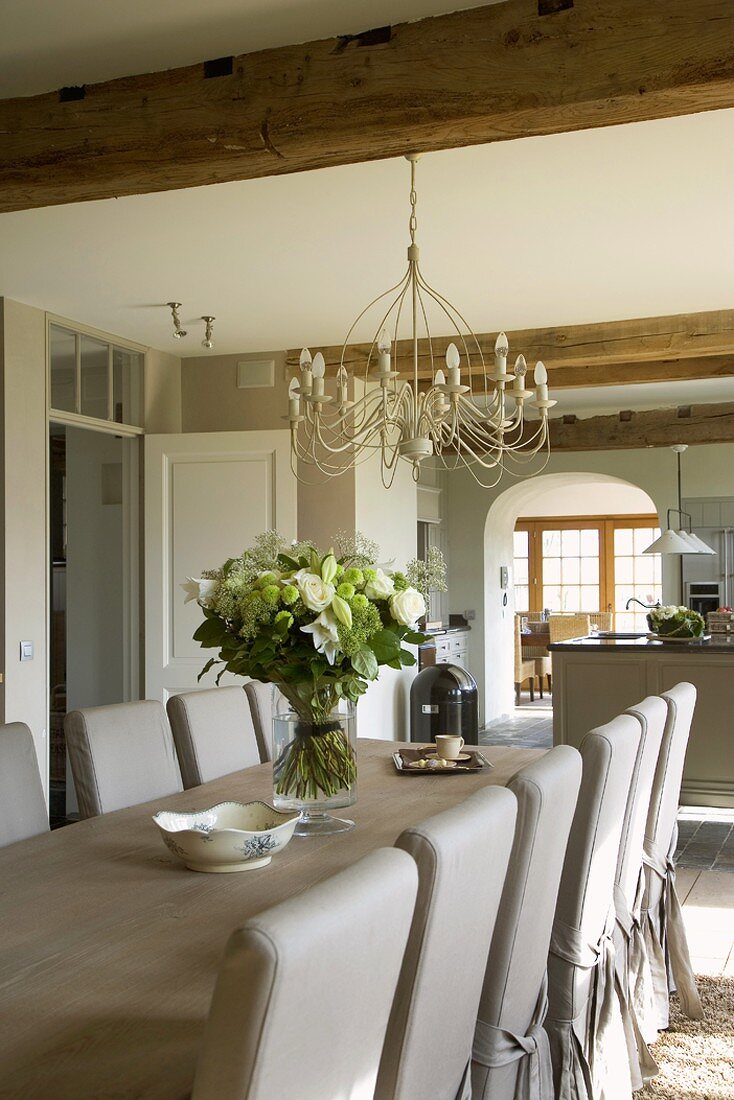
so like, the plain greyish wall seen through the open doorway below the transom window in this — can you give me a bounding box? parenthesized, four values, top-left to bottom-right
(66, 428, 125, 711)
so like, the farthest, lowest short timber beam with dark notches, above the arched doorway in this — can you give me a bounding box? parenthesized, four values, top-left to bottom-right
(550, 402, 734, 451)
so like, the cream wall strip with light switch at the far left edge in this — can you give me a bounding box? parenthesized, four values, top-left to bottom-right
(0, 298, 48, 789)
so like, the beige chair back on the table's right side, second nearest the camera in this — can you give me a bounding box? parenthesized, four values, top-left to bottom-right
(374, 787, 517, 1100)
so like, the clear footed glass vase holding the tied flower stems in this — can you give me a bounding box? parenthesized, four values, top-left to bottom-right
(273, 693, 357, 836)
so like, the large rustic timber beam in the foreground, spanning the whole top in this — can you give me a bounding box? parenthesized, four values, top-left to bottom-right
(0, 0, 734, 211)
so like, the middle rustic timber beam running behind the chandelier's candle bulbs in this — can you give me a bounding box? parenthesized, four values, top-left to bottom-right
(286, 309, 734, 389)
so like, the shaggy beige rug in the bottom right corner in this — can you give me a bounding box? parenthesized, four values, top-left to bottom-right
(636, 977, 734, 1100)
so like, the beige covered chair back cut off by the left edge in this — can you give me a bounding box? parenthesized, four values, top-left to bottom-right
(0, 722, 48, 848)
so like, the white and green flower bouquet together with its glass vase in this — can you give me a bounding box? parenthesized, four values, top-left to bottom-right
(187, 531, 446, 834)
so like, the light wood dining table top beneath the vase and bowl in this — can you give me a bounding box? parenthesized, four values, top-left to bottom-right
(0, 739, 543, 1100)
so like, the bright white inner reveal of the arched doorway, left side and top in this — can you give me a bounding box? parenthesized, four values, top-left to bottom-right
(480, 471, 660, 723)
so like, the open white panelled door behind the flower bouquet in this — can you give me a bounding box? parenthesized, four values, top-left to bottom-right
(145, 430, 297, 702)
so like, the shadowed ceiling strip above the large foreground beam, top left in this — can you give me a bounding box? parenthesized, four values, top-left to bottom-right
(0, 0, 484, 98)
